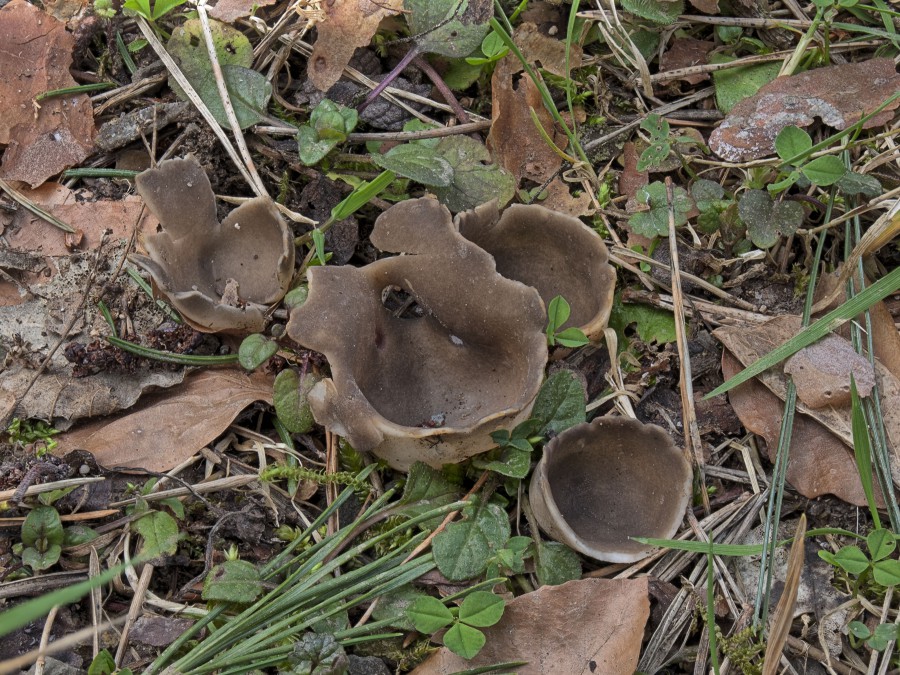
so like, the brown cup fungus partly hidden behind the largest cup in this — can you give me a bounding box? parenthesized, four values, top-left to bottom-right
(456, 201, 616, 339)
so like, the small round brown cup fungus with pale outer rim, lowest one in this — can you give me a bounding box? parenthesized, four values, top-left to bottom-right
(529, 417, 691, 562)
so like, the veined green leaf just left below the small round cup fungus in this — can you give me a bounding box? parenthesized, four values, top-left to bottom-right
(432, 500, 510, 581)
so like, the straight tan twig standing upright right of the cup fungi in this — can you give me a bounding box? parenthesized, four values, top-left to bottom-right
(666, 176, 710, 515)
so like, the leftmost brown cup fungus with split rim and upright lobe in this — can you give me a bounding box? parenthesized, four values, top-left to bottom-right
(130, 156, 294, 333)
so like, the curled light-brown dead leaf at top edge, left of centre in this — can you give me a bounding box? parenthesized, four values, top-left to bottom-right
(307, 0, 403, 91)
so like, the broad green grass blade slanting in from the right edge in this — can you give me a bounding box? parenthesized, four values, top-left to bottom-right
(703, 267, 900, 400)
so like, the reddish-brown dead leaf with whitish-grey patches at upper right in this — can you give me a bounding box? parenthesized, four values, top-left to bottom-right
(709, 58, 900, 162)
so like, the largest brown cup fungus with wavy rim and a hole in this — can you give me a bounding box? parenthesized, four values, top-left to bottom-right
(287, 199, 547, 469)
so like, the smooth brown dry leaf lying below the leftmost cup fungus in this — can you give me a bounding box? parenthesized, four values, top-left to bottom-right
(54, 369, 274, 471)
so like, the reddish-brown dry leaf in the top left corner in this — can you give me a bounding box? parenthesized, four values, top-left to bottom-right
(0, 0, 94, 187)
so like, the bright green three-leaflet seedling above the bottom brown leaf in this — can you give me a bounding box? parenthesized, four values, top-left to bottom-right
(406, 591, 506, 659)
